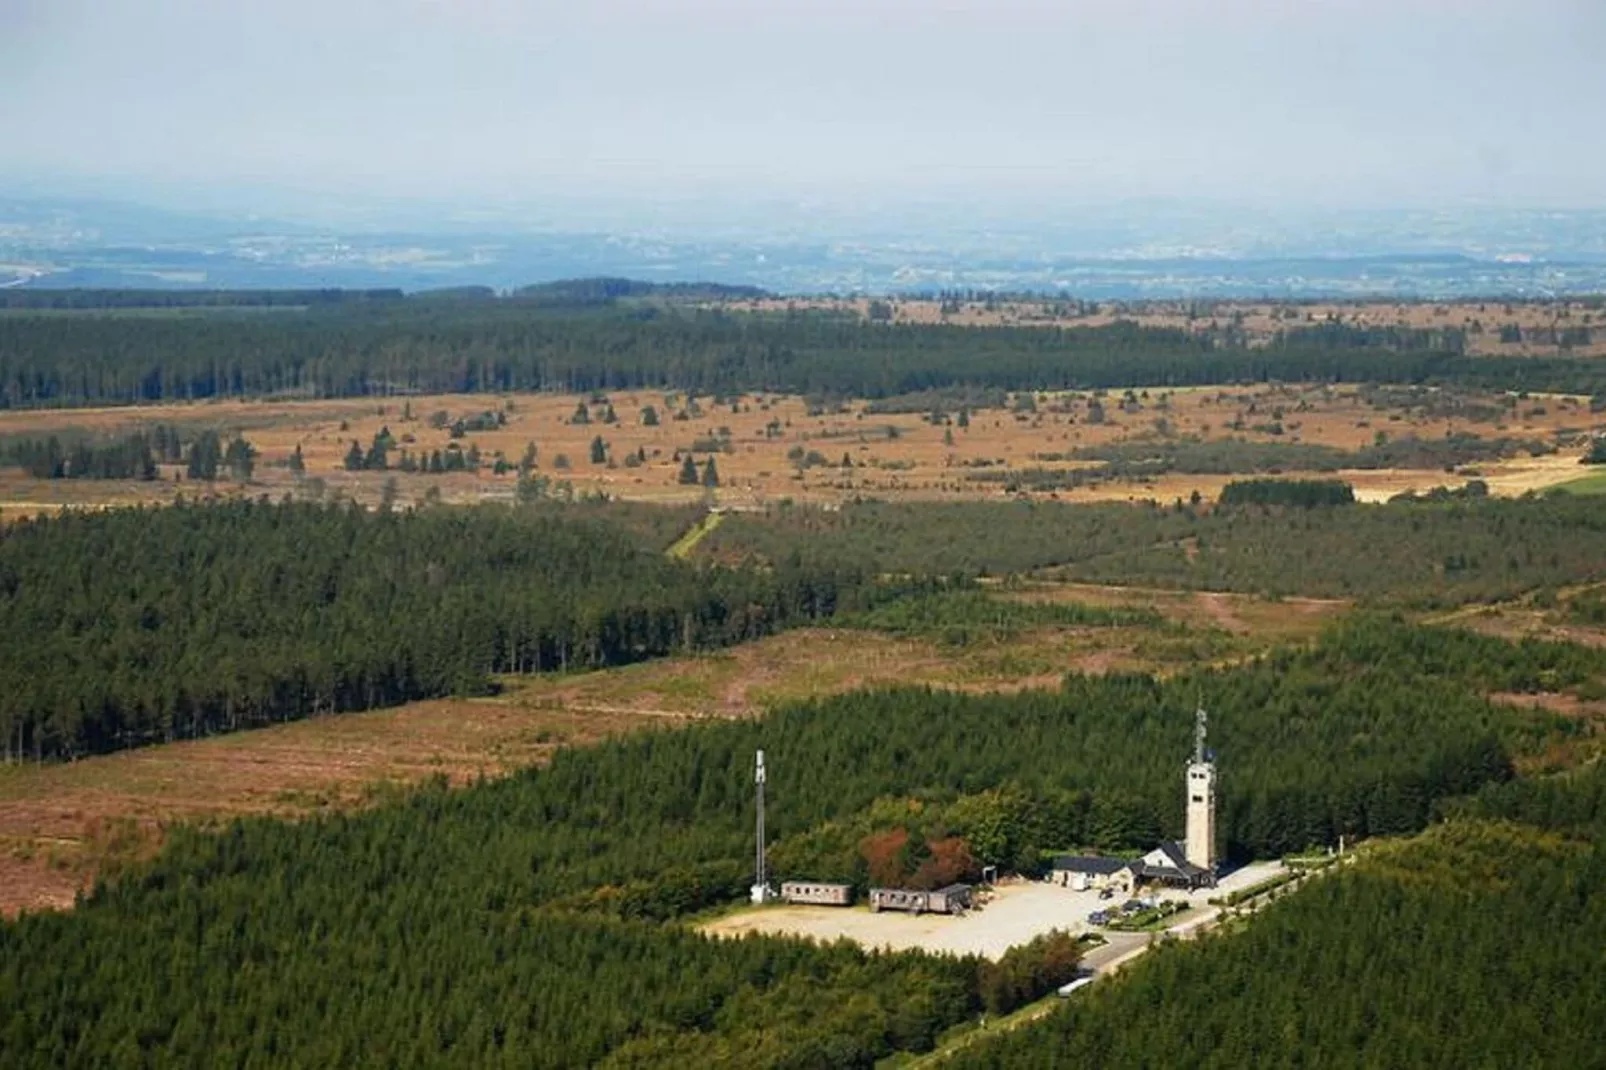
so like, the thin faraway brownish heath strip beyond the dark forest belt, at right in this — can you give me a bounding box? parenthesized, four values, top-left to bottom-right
(734, 297, 1606, 357)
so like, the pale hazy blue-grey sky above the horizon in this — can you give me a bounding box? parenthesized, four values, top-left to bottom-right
(0, 0, 1606, 215)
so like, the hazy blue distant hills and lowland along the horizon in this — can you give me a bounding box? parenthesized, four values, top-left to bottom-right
(9, 193, 1606, 304)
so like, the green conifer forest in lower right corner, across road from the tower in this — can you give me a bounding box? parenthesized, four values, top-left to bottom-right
(948, 765, 1606, 1070)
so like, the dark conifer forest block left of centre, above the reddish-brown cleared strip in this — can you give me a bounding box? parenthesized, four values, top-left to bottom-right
(0, 501, 880, 758)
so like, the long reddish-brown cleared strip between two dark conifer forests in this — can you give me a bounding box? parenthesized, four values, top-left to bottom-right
(0, 585, 1343, 916)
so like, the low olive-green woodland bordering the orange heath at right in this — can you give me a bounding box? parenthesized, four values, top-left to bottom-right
(699, 485, 1606, 607)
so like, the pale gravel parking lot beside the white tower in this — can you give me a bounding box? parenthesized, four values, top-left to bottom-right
(703, 863, 1280, 959)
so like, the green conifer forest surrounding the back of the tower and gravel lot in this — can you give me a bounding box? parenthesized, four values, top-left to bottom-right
(0, 619, 1580, 1067)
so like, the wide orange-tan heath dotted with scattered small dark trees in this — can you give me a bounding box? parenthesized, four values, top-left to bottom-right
(0, 386, 1606, 519)
